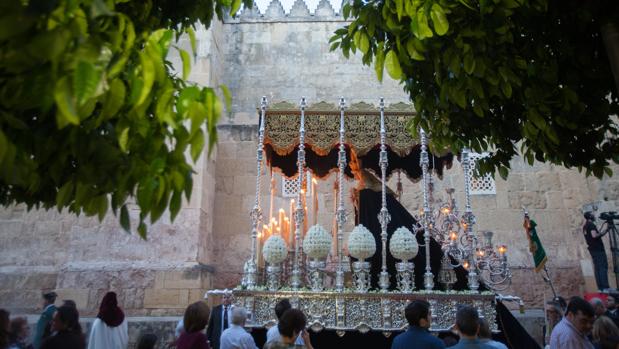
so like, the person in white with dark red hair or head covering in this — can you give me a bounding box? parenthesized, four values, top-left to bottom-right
(88, 292, 129, 349)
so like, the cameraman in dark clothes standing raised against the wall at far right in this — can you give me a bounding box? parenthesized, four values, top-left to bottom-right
(582, 212, 609, 291)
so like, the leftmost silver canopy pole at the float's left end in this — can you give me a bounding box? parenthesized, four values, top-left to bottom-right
(241, 96, 267, 289)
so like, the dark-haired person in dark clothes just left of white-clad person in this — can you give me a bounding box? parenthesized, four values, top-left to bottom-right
(41, 305, 86, 349)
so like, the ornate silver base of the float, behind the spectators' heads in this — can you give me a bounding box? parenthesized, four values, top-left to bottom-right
(232, 290, 497, 334)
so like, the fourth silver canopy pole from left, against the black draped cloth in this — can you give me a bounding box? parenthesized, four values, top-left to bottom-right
(378, 97, 391, 292)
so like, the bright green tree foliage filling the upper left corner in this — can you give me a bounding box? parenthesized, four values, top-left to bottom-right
(0, 0, 251, 237)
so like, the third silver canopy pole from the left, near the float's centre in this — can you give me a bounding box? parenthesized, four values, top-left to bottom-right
(335, 97, 346, 292)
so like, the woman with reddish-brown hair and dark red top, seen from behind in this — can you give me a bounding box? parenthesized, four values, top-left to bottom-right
(176, 302, 211, 349)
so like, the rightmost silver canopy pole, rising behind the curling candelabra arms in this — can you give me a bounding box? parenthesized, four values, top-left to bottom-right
(462, 148, 479, 290)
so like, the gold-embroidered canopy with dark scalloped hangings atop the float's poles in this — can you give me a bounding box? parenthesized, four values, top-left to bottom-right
(265, 102, 453, 181)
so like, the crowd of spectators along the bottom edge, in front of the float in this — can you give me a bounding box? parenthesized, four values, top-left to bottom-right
(0, 292, 619, 349)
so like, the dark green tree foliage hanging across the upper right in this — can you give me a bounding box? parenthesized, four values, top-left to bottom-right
(331, 0, 619, 177)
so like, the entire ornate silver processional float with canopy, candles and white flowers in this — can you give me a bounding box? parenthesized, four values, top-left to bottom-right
(232, 97, 511, 336)
